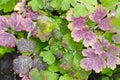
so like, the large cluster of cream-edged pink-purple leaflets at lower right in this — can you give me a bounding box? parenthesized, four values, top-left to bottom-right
(81, 37, 120, 73)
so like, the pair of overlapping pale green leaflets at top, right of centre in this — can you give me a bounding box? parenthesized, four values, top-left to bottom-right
(74, 0, 97, 17)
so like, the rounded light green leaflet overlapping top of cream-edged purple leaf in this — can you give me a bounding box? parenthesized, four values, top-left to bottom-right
(74, 4, 88, 17)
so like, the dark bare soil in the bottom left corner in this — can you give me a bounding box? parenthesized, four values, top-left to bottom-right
(0, 53, 21, 80)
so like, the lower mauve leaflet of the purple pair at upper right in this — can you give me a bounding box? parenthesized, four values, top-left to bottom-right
(99, 18, 112, 31)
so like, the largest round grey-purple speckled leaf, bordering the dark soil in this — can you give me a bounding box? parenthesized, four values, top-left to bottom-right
(13, 55, 32, 75)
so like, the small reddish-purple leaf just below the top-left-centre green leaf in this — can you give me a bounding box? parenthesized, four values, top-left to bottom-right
(25, 7, 39, 20)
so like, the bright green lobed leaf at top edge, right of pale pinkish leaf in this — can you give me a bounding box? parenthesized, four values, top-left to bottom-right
(28, 0, 45, 11)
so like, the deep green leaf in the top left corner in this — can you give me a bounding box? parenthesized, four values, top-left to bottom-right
(0, 0, 17, 12)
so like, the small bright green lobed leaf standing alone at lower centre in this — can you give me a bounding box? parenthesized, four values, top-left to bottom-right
(40, 51, 55, 64)
